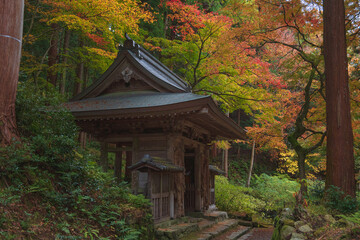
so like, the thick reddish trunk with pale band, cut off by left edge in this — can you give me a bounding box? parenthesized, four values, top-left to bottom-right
(0, 0, 24, 145)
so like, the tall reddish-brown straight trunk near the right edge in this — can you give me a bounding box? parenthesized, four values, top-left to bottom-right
(323, 0, 355, 197)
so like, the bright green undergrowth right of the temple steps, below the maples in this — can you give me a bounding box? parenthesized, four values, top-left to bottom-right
(215, 158, 360, 239)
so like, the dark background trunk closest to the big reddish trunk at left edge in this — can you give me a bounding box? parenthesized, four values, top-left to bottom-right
(47, 23, 59, 87)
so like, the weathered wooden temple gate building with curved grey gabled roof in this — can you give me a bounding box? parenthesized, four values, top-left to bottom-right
(67, 38, 245, 222)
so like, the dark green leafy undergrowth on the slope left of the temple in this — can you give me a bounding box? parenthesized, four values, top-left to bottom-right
(0, 83, 153, 240)
